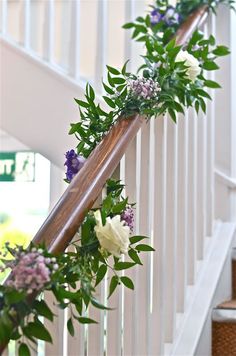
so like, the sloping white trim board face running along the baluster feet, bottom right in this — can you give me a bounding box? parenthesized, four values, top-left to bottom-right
(169, 222, 236, 356)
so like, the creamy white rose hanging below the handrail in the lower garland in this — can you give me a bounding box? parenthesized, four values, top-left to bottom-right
(94, 210, 130, 257)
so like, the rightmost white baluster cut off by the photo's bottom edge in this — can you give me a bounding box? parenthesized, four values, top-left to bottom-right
(149, 117, 167, 355)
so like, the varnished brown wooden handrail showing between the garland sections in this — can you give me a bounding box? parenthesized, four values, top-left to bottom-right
(0, 6, 208, 354)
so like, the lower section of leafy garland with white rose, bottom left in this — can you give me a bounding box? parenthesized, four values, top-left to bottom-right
(0, 180, 154, 356)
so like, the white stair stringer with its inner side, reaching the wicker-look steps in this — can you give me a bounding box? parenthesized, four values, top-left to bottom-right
(171, 222, 236, 356)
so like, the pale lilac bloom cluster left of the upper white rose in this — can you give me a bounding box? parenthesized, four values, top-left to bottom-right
(129, 78, 161, 100)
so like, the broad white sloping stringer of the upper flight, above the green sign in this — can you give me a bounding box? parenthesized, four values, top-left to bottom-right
(0, 39, 84, 168)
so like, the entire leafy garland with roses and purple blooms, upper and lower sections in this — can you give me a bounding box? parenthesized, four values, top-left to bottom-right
(0, 0, 234, 356)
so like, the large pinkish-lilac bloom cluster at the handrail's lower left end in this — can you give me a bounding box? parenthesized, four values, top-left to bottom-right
(2, 247, 59, 294)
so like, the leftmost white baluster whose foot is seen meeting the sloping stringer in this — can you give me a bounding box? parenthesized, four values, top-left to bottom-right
(164, 118, 178, 342)
